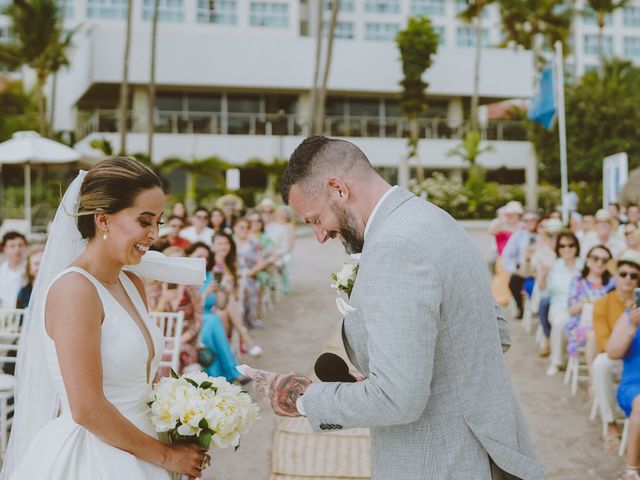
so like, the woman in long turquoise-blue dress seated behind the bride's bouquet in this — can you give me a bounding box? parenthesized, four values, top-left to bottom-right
(187, 242, 241, 382)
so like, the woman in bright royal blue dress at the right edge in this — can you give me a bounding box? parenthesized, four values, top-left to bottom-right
(606, 254, 640, 480)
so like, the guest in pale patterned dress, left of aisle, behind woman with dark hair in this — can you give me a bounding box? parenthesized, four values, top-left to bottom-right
(233, 217, 267, 328)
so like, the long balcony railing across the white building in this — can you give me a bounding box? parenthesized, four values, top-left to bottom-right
(76, 110, 527, 141)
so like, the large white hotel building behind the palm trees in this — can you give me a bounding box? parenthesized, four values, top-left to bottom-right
(0, 0, 640, 186)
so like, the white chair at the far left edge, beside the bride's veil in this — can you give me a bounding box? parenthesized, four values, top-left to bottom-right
(0, 308, 26, 454)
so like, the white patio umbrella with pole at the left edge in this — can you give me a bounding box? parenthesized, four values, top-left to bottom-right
(0, 131, 82, 232)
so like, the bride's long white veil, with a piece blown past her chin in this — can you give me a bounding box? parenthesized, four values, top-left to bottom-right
(0, 171, 206, 480)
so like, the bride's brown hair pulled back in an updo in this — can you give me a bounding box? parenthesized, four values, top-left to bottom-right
(78, 157, 163, 239)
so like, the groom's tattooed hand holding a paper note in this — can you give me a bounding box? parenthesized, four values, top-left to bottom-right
(242, 366, 313, 417)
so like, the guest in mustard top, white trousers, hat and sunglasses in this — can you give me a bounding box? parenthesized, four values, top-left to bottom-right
(591, 253, 640, 452)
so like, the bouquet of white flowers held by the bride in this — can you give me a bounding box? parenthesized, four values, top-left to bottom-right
(148, 370, 260, 449)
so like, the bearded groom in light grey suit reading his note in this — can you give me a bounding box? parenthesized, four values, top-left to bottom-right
(242, 136, 543, 480)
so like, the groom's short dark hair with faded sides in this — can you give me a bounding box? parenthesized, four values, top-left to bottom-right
(280, 135, 375, 205)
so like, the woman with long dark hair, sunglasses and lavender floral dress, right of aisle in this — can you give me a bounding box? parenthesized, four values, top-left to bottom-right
(566, 245, 615, 367)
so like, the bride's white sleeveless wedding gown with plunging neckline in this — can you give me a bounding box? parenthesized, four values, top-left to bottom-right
(11, 267, 171, 480)
